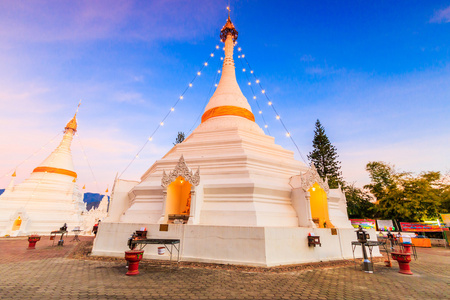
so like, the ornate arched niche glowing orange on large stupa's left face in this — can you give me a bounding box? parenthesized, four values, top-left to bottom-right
(159, 155, 200, 224)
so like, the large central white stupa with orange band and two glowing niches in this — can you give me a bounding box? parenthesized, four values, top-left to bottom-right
(93, 17, 372, 266)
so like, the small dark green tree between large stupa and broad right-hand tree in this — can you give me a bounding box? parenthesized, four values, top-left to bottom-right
(344, 184, 375, 219)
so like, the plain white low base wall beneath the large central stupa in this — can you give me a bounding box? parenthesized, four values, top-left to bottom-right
(92, 222, 381, 267)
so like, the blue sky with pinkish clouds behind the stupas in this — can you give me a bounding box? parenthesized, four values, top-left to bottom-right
(0, 0, 450, 192)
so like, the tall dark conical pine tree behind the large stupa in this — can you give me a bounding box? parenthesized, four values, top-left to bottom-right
(308, 120, 344, 189)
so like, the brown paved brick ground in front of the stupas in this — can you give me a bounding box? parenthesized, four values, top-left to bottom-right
(0, 237, 450, 299)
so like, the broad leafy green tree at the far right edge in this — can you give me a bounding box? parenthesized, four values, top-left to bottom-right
(365, 162, 450, 222)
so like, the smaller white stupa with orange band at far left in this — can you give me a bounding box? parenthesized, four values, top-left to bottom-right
(0, 114, 85, 236)
